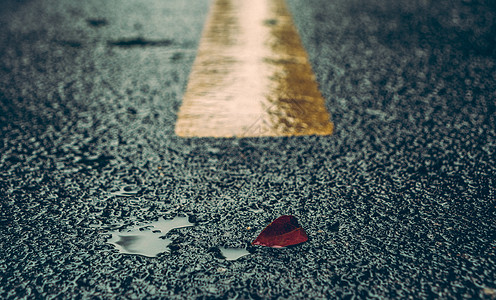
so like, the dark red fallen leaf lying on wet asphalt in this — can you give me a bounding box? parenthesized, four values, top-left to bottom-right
(251, 216, 308, 248)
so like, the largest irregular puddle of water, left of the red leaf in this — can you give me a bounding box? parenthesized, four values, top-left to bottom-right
(107, 217, 194, 257)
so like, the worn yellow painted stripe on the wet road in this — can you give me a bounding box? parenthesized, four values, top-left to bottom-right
(175, 0, 333, 137)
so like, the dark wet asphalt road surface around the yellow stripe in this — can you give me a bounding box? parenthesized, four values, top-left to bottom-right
(0, 0, 496, 299)
